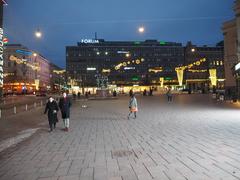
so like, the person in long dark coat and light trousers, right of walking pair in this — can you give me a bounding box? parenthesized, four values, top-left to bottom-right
(58, 92, 72, 131)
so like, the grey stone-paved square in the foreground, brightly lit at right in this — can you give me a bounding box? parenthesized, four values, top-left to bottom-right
(0, 95, 240, 180)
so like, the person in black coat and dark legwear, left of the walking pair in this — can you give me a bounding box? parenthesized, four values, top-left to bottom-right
(44, 97, 59, 132)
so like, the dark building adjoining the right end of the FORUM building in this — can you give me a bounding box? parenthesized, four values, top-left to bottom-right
(184, 42, 225, 90)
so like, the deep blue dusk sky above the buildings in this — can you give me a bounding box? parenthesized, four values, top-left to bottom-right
(4, 0, 234, 67)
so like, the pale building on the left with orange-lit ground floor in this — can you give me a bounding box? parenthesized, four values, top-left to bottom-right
(3, 44, 51, 94)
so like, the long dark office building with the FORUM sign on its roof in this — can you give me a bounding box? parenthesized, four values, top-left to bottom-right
(66, 39, 184, 86)
